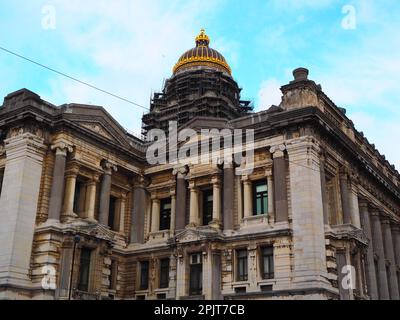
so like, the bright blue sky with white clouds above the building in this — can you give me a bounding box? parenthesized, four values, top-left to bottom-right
(0, 0, 400, 168)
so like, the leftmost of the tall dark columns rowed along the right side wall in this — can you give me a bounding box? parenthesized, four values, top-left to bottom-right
(360, 202, 379, 300)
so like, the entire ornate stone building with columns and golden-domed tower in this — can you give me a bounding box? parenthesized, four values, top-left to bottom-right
(0, 32, 400, 300)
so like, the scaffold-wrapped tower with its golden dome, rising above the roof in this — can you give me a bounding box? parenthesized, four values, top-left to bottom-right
(143, 30, 251, 134)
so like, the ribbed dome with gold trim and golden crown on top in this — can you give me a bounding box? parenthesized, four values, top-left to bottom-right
(173, 29, 231, 75)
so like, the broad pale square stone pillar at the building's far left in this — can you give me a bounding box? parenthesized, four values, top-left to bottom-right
(0, 132, 47, 290)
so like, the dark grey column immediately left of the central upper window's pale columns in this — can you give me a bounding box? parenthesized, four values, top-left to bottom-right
(173, 166, 188, 231)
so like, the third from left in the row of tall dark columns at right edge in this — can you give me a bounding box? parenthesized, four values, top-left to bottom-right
(382, 219, 400, 300)
